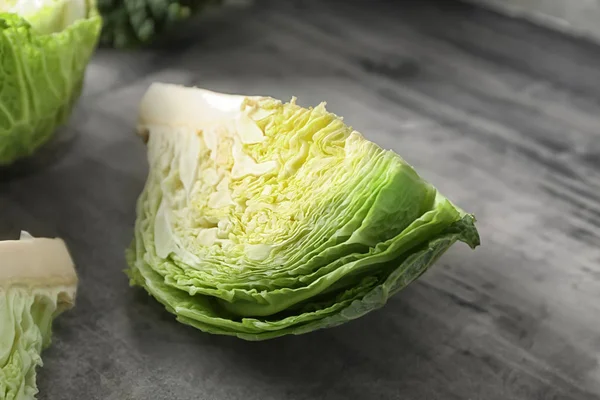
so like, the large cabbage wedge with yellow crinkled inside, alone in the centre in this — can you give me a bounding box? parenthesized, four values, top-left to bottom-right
(127, 83, 479, 340)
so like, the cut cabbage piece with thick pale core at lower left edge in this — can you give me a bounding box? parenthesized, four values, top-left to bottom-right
(0, 232, 77, 400)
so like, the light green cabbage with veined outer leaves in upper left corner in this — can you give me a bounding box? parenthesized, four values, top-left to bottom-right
(0, 0, 102, 165)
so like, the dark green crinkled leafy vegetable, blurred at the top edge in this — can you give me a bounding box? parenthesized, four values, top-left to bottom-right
(98, 0, 221, 48)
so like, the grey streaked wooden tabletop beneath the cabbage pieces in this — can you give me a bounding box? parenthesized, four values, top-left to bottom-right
(0, 0, 600, 400)
